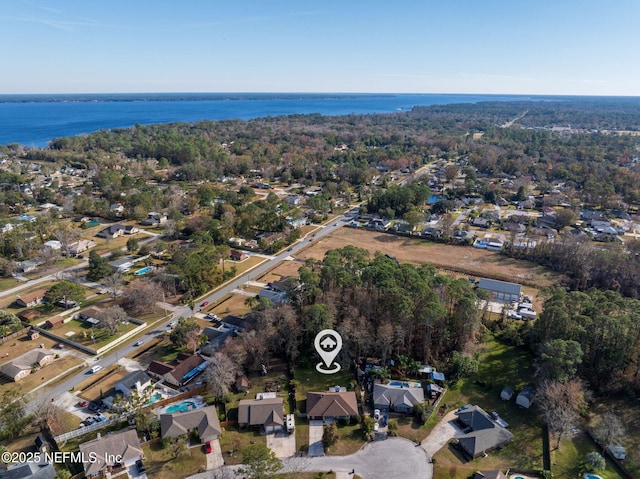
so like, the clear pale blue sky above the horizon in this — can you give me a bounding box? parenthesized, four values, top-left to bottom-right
(0, 0, 640, 96)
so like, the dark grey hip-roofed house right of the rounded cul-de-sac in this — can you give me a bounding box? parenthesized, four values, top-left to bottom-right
(456, 406, 513, 459)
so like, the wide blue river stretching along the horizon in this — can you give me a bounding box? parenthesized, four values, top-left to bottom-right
(0, 93, 544, 147)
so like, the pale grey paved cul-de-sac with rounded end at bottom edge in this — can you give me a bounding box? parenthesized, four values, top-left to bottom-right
(283, 437, 433, 479)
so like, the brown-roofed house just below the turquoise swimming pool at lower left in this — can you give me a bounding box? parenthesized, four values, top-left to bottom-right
(160, 406, 222, 442)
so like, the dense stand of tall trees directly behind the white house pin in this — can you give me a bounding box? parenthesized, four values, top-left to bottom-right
(225, 246, 481, 373)
